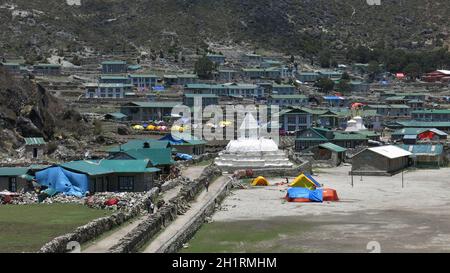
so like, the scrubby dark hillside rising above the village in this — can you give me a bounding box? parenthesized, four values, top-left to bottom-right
(0, 0, 450, 60)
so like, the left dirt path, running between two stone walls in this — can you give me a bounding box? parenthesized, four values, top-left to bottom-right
(82, 186, 181, 253)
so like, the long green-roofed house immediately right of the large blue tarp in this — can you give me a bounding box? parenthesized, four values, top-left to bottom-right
(60, 159, 161, 193)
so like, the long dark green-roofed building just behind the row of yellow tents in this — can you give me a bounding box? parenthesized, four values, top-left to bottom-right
(120, 101, 181, 121)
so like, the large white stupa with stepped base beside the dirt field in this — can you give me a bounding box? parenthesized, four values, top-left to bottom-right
(215, 113, 293, 171)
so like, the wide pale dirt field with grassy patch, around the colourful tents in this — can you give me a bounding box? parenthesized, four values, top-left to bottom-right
(184, 167, 450, 252)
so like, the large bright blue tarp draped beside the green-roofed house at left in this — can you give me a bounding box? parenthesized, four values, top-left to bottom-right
(36, 167, 89, 197)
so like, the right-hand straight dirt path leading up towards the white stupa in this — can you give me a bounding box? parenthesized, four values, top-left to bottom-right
(143, 176, 229, 253)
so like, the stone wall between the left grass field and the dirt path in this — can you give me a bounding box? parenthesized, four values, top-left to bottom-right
(39, 188, 159, 253)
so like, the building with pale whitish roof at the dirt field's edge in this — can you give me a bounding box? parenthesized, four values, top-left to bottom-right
(351, 145, 412, 176)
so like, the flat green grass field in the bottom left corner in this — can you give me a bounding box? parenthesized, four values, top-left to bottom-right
(0, 204, 112, 253)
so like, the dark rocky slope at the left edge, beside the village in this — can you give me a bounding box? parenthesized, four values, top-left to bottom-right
(0, 68, 90, 153)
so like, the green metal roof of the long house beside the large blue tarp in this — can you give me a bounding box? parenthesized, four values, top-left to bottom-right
(61, 159, 160, 175)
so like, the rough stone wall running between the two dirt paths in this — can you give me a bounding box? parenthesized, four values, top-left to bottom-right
(109, 165, 222, 253)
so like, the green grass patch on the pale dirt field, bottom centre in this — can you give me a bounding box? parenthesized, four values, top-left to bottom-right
(181, 217, 311, 253)
